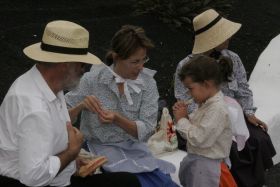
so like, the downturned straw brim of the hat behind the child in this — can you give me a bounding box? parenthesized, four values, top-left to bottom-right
(192, 18, 241, 54)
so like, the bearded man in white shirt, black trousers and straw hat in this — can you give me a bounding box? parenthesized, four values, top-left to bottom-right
(0, 20, 139, 187)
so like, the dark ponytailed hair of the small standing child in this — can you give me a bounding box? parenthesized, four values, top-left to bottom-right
(179, 55, 233, 85)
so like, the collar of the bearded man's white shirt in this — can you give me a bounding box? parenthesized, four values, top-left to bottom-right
(31, 65, 63, 102)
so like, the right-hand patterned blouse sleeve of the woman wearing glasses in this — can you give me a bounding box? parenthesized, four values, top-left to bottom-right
(135, 80, 159, 141)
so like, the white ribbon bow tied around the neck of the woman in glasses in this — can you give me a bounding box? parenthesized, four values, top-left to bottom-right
(108, 65, 156, 105)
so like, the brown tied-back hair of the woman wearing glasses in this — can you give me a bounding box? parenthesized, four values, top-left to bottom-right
(105, 25, 154, 65)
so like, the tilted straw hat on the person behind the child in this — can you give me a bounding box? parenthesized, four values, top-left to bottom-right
(192, 9, 241, 54)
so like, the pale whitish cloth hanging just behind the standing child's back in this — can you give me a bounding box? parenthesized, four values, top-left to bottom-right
(224, 96, 250, 151)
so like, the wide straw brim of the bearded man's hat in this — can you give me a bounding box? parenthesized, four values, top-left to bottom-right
(23, 42, 102, 64)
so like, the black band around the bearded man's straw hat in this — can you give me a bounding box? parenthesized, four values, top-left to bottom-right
(41, 42, 88, 55)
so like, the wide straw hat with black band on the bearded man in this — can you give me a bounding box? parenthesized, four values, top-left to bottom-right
(23, 20, 101, 64)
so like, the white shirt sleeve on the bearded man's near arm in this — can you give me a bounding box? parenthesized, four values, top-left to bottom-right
(18, 111, 60, 186)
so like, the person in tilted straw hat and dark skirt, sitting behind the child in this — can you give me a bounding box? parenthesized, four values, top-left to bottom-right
(174, 9, 275, 186)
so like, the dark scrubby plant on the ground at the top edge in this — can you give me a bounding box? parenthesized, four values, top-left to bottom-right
(135, 0, 233, 30)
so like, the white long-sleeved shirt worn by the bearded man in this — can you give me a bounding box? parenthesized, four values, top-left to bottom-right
(0, 66, 76, 186)
